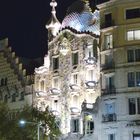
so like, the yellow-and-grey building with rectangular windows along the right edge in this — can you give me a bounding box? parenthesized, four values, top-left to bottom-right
(98, 0, 140, 140)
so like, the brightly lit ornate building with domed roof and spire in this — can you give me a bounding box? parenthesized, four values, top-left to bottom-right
(34, 0, 100, 140)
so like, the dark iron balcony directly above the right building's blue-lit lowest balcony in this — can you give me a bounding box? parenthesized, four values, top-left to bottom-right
(101, 86, 116, 96)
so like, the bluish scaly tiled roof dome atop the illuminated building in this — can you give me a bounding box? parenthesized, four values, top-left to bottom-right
(61, 0, 100, 35)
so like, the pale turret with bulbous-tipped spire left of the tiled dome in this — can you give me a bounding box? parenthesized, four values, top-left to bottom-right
(46, 0, 61, 40)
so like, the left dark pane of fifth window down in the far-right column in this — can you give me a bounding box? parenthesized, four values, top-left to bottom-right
(129, 98, 136, 115)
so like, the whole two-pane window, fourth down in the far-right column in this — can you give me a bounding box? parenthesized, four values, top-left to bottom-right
(128, 72, 140, 87)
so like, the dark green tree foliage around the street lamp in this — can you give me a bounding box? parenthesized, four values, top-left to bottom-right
(0, 103, 60, 140)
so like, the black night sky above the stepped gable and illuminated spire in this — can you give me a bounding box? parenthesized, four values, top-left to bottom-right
(0, 0, 103, 58)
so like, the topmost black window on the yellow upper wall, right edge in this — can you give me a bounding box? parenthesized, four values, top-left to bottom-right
(126, 8, 140, 19)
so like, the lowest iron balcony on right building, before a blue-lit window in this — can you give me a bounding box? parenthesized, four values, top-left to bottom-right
(102, 113, 117, 122)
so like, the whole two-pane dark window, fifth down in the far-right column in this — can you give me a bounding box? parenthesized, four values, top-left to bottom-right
(128, 98, 140, 115)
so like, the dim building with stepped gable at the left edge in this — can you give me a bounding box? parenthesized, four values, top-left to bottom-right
(0, 39, 33, 114)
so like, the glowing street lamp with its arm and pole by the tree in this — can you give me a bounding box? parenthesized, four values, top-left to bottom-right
(19, 120, 41, 140)
